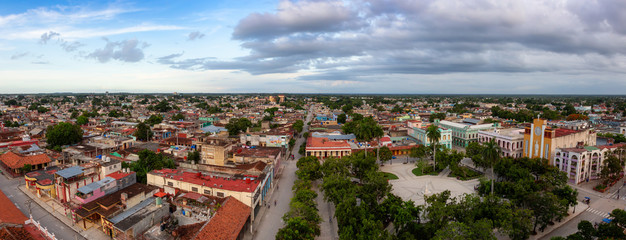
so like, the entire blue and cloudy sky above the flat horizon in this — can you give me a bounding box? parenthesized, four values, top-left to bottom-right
(0, 0, 626, 95)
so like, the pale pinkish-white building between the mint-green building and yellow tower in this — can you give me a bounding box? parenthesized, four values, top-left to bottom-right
(478, 128, 524, 158)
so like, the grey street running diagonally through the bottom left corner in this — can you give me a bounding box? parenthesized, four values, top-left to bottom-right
(0, 171, 85, 240)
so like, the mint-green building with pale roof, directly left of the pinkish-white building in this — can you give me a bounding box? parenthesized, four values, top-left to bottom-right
(435, 120, 495, 147)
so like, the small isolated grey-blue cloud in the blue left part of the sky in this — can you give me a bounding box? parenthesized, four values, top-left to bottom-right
(87, 38, 150, 63)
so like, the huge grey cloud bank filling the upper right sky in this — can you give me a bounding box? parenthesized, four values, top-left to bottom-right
(164, 0, 626, 85)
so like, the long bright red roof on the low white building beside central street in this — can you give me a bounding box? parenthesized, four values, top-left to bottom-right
(150, 169, 259, 193)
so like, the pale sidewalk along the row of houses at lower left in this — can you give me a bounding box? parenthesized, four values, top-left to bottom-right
(18, 186, 109, 240)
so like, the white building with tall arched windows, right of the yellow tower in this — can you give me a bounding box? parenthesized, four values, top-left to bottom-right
(551, 144, 624, 184)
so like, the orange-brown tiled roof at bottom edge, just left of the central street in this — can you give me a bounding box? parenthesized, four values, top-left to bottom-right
(194, 197, 251, 240)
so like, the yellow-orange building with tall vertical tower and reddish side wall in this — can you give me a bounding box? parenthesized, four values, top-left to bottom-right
(523, 119, 597, 159)
